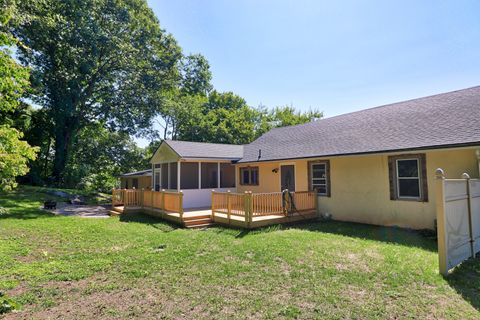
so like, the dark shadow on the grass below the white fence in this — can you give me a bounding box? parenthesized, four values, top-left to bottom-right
(445, 255, 480, 311)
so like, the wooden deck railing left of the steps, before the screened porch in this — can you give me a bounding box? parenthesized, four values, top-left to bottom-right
(112, 189, 183, 218)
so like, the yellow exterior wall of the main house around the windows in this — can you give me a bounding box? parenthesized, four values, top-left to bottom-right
(236, 148, 479, 229)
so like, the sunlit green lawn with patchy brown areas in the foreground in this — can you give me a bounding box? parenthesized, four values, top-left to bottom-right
(0, 187, 480, 319)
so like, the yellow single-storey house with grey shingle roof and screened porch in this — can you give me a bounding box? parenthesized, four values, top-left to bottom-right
(118, 86, 480, 229)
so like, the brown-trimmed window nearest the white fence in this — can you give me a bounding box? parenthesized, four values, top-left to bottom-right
(389, 154, 427, 201)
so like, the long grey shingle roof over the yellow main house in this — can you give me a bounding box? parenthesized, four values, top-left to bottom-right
(239, 86, 480, 162)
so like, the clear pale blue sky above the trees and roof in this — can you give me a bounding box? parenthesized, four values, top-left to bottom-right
(138, 0, 480, 145)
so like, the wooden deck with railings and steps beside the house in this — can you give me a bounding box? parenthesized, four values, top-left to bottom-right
(111, 190, 318, 229)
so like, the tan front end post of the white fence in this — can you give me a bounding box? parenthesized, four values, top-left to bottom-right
(435, 168, 448, 276)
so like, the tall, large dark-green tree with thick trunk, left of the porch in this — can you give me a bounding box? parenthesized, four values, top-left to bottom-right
(9, 0, 181, 183)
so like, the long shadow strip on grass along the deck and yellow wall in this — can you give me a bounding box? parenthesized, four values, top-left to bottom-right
(232, 220, 437, 252)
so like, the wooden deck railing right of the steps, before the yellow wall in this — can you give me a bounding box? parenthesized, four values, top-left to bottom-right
(212, 191, 317, 223)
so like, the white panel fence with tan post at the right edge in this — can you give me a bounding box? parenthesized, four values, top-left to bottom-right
(435, 169, 480, 275)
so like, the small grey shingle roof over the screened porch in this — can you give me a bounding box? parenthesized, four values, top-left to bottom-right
(164, 140, 243, 160)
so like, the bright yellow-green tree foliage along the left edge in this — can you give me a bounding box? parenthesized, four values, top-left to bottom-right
(0, 2, 37, 190)
